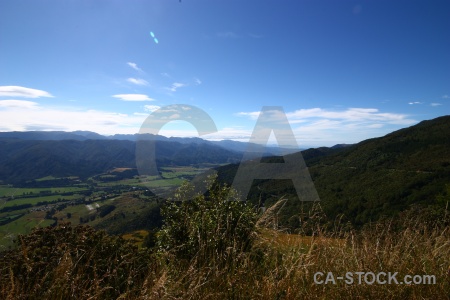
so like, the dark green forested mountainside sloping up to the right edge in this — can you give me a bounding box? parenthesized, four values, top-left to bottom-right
(217, 116, 450, 228)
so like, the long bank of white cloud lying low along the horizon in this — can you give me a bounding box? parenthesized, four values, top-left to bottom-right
(0, 98, 424, 148)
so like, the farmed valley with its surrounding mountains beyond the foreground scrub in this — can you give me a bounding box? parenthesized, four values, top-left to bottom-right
(0, 116, 450, 247)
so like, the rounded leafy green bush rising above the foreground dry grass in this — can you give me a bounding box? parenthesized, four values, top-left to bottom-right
(157, 177, 257, 265)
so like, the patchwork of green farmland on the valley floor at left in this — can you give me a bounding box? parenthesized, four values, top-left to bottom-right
(0, 166, 211, 249)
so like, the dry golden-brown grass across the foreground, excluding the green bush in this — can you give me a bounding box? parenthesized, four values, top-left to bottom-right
(0, 210, 450, 300)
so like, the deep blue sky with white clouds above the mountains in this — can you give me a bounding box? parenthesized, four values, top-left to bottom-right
(0, 0, 450, 148)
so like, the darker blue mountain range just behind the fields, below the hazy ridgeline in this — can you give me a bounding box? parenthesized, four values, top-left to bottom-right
(0, 139, 242, 183)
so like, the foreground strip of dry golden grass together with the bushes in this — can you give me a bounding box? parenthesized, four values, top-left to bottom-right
(0, 178, 450, 299)
